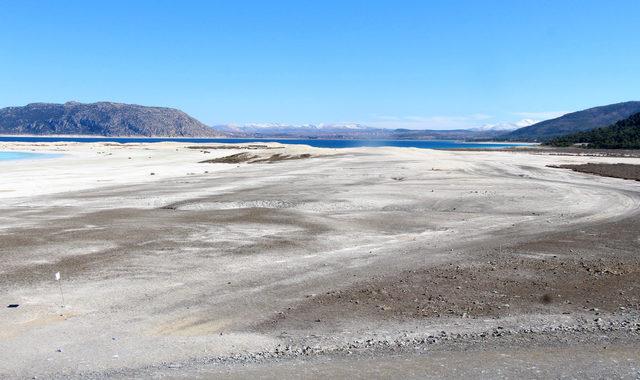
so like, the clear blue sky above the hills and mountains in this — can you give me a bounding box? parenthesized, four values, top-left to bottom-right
(0, 0, 640, 128)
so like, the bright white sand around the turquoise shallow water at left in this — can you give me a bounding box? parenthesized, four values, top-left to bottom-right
(0, 143, 236, 198)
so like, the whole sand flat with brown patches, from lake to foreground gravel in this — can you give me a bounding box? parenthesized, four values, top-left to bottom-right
(0, 143, 640, 377)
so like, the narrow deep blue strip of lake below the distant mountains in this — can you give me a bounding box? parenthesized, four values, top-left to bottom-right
(0, 136, 527, 149)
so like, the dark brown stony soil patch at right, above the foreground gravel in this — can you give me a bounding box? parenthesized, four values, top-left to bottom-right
(258, 216, 640, 330)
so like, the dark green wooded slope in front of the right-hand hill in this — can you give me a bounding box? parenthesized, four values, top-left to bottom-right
(548, 112, 640, 149)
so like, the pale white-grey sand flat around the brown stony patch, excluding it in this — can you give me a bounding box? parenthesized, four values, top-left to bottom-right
(0, 143, 640, 377)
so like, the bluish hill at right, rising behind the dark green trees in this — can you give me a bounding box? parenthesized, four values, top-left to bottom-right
(500, 102, 640, 141)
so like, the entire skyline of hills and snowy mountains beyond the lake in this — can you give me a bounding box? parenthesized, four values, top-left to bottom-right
(0, 102, 640, 141)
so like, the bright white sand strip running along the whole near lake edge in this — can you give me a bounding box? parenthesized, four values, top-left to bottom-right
(0, 142, 638, 198)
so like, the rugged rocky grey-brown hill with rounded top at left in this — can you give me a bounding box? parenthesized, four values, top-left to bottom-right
(0, 102, 221, 137)
